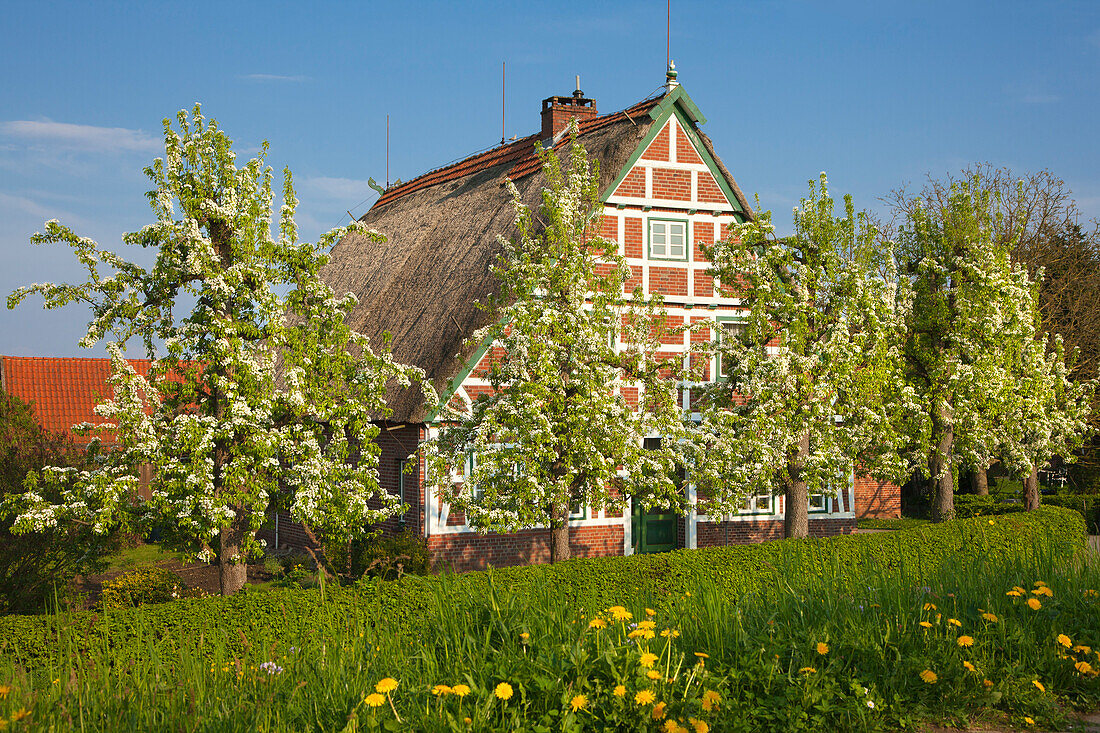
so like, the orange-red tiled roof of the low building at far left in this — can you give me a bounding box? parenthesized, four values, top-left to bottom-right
(0, 357, 194, 442)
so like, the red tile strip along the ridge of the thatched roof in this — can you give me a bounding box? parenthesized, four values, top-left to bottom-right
(371, 94, 663, 208)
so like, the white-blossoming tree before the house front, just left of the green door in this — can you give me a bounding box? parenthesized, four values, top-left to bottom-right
(429, 136, 683, 562)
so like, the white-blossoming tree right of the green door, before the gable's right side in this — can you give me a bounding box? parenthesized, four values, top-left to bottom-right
(689, 174, 905, 537)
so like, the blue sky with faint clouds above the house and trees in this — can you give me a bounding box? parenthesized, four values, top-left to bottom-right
(0, 0, 1100, 355)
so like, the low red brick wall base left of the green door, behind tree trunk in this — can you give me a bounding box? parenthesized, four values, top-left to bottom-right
(428, 525, 623, 571)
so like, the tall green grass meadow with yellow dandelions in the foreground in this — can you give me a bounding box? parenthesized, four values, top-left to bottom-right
(0, 517, 1100, 733)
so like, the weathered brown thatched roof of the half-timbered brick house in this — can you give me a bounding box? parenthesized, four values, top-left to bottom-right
(321, 88, 750, 423)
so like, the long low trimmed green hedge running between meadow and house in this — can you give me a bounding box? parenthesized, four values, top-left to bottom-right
(0, 507, 1085, 667)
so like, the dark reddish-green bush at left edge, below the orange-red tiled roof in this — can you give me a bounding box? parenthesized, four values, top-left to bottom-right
(0, 391, 120, 613)
